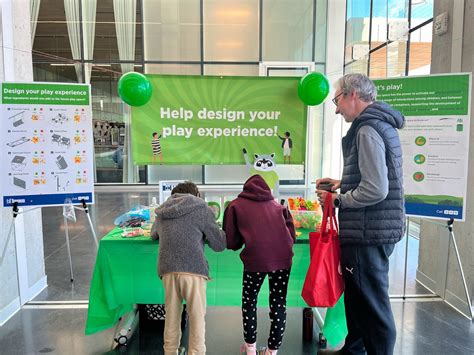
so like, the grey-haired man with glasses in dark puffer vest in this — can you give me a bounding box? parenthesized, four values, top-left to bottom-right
(316, 74, 405, 355)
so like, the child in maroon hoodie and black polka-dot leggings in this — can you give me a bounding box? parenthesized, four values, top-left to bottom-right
(223, 175, 295, 354)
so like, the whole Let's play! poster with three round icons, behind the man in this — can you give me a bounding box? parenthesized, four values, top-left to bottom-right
(375, 74, 471, 220)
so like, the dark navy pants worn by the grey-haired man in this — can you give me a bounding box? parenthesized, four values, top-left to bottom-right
(341, 244, 397, 355)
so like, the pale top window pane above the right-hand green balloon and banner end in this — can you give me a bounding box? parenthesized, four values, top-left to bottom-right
(262, 0, 314, 61)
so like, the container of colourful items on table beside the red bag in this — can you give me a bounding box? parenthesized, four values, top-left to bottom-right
(288, 197, 322, 230)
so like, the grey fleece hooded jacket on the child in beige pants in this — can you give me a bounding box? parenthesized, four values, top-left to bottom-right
(151, 194, 226, 277)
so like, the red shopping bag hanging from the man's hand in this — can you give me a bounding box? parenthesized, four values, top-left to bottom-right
(301, 194, 344, 307)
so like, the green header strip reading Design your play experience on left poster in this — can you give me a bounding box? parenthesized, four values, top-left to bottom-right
(2, 83, 90, 105)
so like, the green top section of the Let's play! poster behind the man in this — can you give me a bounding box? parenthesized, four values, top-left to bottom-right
(374, 75, 469, 116)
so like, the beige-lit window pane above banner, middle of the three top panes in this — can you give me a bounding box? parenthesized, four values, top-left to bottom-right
(203, 0, 259, 62)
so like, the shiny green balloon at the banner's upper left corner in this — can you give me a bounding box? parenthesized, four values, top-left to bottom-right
(118, 72, 153, 106)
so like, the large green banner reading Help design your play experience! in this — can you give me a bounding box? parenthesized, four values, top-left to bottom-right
(132, 75, 306, 165)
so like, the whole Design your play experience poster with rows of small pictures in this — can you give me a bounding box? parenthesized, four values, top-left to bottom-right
(0, 82, 94, 207)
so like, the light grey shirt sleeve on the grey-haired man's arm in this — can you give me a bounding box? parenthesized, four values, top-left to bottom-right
(340, 126, 388, 208)
